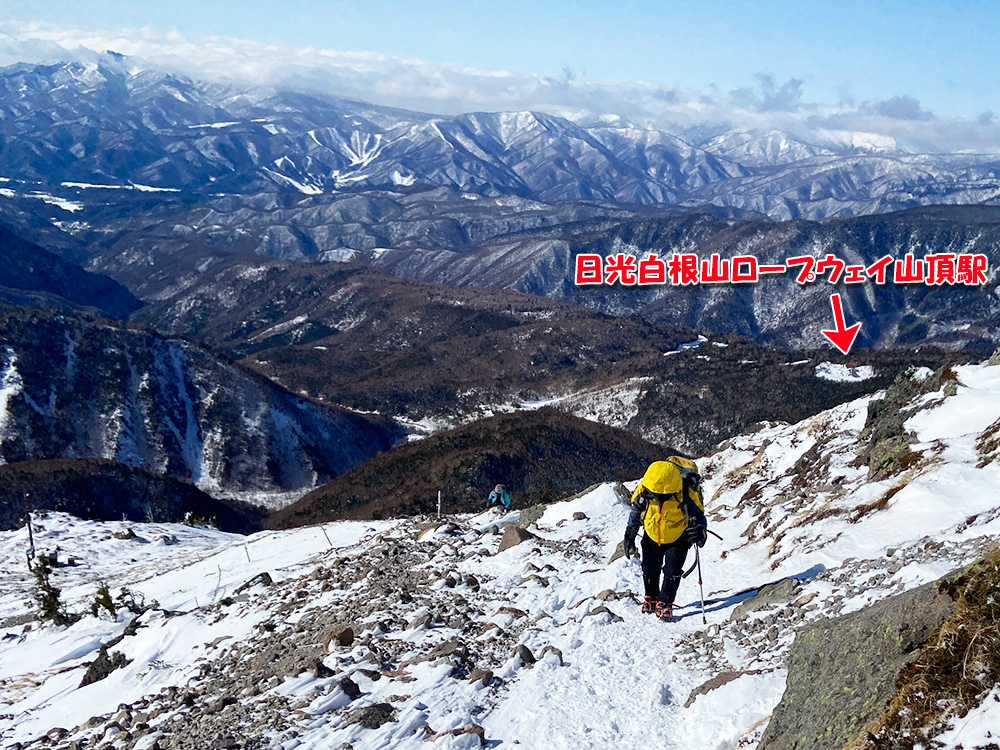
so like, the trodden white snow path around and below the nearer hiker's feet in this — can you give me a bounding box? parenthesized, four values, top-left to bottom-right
(472, 487, 784, 748)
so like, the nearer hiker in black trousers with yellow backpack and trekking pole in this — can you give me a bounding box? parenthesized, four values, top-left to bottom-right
(625, 456, 708, 620)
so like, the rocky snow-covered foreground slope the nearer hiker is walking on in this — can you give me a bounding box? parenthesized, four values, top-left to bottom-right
(0, 366, 1000, 750)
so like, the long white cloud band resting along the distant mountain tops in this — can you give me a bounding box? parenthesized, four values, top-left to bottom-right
(0, 22, 1000, 152)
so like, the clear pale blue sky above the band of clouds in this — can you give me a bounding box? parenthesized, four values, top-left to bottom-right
(7, 0, 1000, 116)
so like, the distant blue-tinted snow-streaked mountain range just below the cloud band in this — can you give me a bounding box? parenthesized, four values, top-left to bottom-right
(0, 60, 1000, 219)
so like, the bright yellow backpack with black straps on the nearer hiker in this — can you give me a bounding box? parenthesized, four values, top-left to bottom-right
(632, 456, 705, 544)
